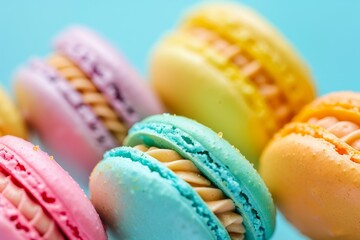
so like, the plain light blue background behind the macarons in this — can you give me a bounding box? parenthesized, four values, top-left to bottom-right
(0, 0, 360, 239)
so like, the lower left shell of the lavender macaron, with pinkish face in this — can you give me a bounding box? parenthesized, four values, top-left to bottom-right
(14, 61, 116, 178)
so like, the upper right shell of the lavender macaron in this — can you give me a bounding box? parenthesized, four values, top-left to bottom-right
(54, 26, 164, 125)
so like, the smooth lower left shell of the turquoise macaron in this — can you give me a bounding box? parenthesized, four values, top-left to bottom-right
(90, 157, 214, 240)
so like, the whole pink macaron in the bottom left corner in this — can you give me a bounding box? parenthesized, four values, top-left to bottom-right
(0, 136, 106, 240)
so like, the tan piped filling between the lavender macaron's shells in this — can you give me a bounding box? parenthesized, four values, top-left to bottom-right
(48, 54, 127, 143)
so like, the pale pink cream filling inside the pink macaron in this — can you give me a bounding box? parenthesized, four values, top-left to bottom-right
(0, 171, 64, 240)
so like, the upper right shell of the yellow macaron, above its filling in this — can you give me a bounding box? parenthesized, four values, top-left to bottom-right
(183, 3, 316, 110)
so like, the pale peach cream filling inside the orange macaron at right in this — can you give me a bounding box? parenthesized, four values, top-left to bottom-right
(308, 116, 360, 151)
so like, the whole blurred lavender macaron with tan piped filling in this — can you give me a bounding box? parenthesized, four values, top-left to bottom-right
(14, 26, 163, 178)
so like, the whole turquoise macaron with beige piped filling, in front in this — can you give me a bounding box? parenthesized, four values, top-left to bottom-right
(89, 114, 275, 240)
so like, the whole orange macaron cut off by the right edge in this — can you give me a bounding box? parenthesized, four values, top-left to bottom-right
(260, 92, 360, 239)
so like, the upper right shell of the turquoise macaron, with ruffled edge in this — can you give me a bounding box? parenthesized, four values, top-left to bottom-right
(124, 114, 275, 239)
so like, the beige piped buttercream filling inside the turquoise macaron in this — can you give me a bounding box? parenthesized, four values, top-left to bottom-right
(134, 145, 245, 240)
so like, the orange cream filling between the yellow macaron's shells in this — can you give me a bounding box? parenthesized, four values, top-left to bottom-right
(189, 28, 293, 126)
